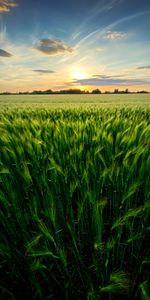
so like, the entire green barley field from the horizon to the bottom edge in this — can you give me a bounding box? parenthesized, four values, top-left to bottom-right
(0, 95, 150, 300)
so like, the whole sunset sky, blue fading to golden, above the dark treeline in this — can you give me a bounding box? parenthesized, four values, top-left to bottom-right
(0, 0, 150, 92)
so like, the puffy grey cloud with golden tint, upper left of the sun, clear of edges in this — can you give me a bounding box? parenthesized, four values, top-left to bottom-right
(35, 39, 74, 55)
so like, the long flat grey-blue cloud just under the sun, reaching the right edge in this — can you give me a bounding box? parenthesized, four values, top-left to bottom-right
(72, 76, 150, 86)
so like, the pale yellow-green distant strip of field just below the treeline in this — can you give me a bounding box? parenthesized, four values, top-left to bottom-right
(0, 94, 150, 108)
